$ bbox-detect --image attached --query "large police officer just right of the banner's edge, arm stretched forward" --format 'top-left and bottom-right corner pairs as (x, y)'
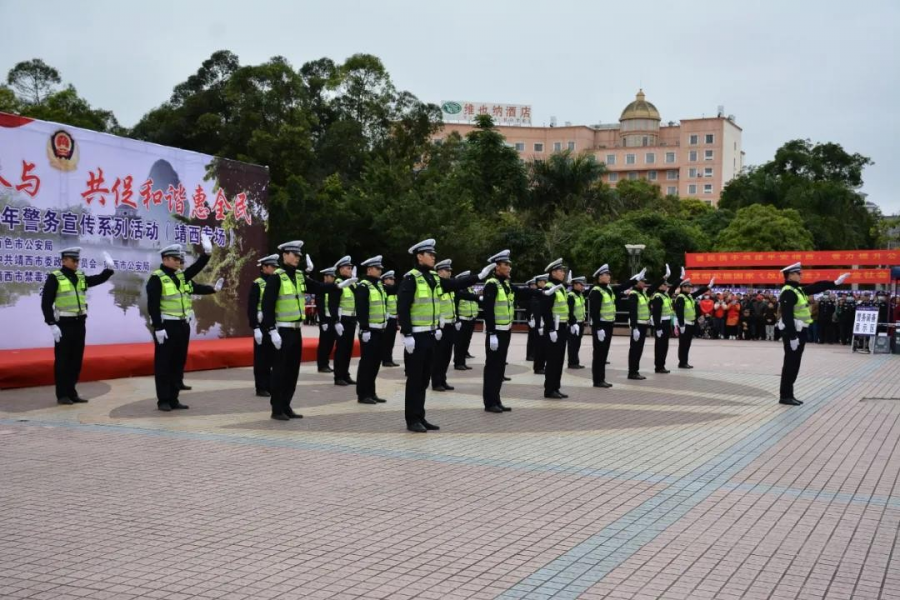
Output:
(262, 240), (355, 421)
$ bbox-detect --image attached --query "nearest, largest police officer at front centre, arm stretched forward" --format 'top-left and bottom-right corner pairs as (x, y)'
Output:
(397, 239), (493, 433)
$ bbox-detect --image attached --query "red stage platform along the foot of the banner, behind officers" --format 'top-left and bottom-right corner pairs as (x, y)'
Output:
(0, 337), (359, 389)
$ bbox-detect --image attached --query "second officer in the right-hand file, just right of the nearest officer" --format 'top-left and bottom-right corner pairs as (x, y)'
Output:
(482, 250), (541, 413)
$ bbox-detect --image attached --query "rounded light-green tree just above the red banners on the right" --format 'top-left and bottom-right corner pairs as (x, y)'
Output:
(716, 204), (815, 252)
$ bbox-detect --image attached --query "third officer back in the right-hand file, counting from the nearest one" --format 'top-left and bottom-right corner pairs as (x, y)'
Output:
(541, 258), (579, 399)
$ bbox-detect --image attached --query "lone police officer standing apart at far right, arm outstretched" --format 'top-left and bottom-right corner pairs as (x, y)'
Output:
(778, 263), (850, 406)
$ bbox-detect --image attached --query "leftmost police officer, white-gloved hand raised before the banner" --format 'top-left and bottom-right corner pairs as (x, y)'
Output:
(41, 247), (115, 404)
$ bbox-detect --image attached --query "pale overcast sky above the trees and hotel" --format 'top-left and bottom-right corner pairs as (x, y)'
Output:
(0, 0), (900, 213)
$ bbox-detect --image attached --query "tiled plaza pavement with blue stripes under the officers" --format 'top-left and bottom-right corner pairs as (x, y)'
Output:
(0, 328), (900, 600)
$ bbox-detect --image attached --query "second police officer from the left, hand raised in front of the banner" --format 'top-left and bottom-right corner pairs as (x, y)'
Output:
(147, 234), (224, 412)
